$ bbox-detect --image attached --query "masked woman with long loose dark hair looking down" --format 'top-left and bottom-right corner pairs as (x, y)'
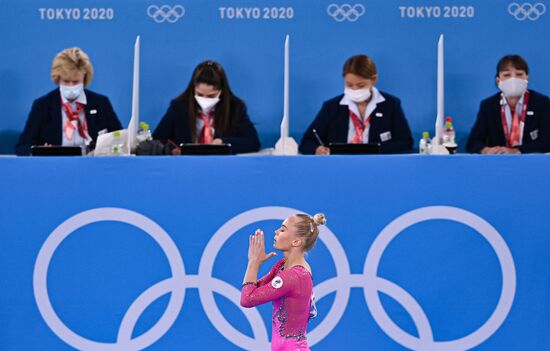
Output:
(153, 61), (260, 155)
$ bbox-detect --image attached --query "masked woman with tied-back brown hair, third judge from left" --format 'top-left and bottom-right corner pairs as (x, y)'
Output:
(300, 55), (413, 155)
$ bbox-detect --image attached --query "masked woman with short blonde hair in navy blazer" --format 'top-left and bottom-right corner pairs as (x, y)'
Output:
(15, 47), (122, 156)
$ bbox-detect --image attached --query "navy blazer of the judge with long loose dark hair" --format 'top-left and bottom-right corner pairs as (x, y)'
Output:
(153, 97), (260, 154)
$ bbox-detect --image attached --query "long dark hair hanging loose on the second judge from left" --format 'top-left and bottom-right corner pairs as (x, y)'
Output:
(176, 60), (234, 140)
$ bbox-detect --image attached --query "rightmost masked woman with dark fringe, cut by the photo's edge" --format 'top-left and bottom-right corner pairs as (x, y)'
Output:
(466, 55), (550, 154)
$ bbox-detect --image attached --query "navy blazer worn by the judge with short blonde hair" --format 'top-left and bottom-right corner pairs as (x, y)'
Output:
(15, 89), (122, 156)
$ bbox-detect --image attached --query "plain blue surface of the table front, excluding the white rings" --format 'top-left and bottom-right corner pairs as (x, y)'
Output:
(0, 155), (550, 351)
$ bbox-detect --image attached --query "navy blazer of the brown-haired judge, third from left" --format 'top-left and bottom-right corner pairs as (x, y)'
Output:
(300, 92), (413, 154)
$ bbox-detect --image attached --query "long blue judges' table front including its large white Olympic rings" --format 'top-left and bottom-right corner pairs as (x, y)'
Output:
(0, 155), (550, 351)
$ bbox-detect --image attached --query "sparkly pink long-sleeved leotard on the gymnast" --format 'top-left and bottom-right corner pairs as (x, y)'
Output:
(241, 259), (313, 351)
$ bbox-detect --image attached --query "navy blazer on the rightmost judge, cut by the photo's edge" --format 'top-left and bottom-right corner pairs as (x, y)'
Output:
(466, 90), (550, 153)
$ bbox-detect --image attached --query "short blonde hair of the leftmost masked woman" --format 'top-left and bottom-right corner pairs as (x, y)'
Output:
(52, 47), (94, 87)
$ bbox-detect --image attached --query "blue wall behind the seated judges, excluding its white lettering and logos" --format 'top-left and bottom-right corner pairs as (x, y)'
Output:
(0, 0), (550, 154)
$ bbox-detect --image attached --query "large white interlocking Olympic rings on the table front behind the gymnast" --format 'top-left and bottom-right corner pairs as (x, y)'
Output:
(33, 206), (516, 351)
